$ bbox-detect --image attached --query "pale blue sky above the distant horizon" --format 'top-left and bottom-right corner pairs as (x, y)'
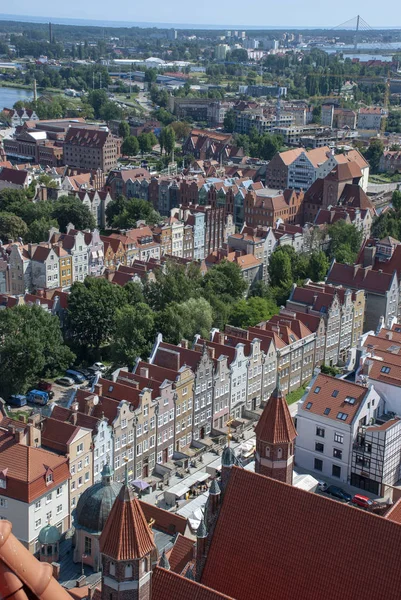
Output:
(0, 0), (394, 30)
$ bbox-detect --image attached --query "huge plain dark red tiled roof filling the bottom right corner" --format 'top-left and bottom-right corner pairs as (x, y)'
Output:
(201, 467), (401, 600)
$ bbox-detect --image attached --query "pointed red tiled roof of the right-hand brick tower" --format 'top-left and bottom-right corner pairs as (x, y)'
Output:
(255, 387), (297, 444)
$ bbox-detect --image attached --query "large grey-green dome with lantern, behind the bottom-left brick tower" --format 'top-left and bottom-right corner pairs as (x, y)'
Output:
(74, 464), (122, 533)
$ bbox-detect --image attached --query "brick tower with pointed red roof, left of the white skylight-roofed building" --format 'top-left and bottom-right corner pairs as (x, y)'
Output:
(255, 377), (297, 484)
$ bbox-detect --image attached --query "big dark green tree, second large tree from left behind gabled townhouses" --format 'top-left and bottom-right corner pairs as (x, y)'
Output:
(66, 277), (126, 349)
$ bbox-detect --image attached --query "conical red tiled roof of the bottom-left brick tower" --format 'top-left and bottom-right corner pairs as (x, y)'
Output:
(99, 485), (155, 560)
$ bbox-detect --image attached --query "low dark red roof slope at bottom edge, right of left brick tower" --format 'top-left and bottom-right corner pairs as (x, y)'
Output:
(152, 567), (233, 600)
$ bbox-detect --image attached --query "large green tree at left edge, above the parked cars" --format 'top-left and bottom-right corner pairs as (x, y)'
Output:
(0, 305), (75, 399)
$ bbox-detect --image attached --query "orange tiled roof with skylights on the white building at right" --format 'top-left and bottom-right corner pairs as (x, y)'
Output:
(302, 373), (368, 425)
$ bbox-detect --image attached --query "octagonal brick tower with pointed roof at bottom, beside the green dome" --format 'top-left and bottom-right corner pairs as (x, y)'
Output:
(99, 470), (157, 600)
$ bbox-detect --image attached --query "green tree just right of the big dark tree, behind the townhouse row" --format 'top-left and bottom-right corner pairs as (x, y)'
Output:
(111, 302), (155, 369)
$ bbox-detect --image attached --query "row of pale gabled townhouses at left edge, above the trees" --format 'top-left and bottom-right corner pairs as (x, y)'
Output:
(6, 225), (103, 295)
